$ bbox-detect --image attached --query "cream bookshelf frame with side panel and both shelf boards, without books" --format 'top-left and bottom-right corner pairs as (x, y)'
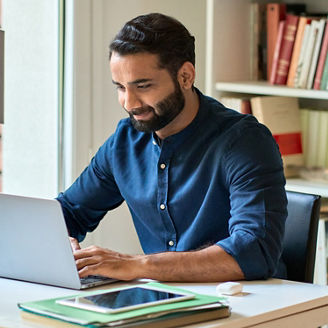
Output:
(205, 0), (328, 198)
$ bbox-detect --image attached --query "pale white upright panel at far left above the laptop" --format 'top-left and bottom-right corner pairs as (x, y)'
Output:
(2, 0), (58, 197)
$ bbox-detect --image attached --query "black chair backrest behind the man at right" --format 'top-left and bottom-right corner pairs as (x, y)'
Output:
(282, 191), (320, 283)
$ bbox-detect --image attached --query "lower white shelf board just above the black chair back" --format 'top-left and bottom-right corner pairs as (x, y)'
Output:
(286, 179), (328, 198)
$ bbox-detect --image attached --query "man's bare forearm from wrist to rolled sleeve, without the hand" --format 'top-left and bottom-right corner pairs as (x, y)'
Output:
(136, 245), (244, 282)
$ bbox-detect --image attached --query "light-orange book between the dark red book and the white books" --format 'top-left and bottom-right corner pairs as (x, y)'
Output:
(287, 16), (309, 87)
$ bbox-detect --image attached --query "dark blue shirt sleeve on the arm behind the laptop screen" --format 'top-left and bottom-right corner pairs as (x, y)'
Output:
(57, 138), (124, 241)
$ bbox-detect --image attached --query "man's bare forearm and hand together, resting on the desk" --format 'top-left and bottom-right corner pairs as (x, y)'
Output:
(74, 245), (244, 282)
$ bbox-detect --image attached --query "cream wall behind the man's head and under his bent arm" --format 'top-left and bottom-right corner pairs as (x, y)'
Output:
(66, 0), (206, 253)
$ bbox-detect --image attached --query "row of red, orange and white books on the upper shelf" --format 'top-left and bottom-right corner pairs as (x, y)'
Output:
(251, 3), (328, 90)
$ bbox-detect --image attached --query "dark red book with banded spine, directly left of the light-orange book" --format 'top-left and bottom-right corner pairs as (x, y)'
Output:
(275, 15), (299, 84)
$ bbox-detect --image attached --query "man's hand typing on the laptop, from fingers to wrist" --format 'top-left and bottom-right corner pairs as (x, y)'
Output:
(74, 246), (142, 280)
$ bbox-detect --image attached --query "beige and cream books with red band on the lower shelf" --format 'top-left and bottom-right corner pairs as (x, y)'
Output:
(219, 95), (328, 177)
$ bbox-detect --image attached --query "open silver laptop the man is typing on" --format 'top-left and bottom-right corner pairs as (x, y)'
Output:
(0, 193), (117, 289)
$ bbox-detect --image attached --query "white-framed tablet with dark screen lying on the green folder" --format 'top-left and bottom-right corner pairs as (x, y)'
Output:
(56, 286), (195, 313)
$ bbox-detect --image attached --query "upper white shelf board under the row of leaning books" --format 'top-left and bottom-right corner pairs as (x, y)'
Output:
(215, 81), (328, 100)
